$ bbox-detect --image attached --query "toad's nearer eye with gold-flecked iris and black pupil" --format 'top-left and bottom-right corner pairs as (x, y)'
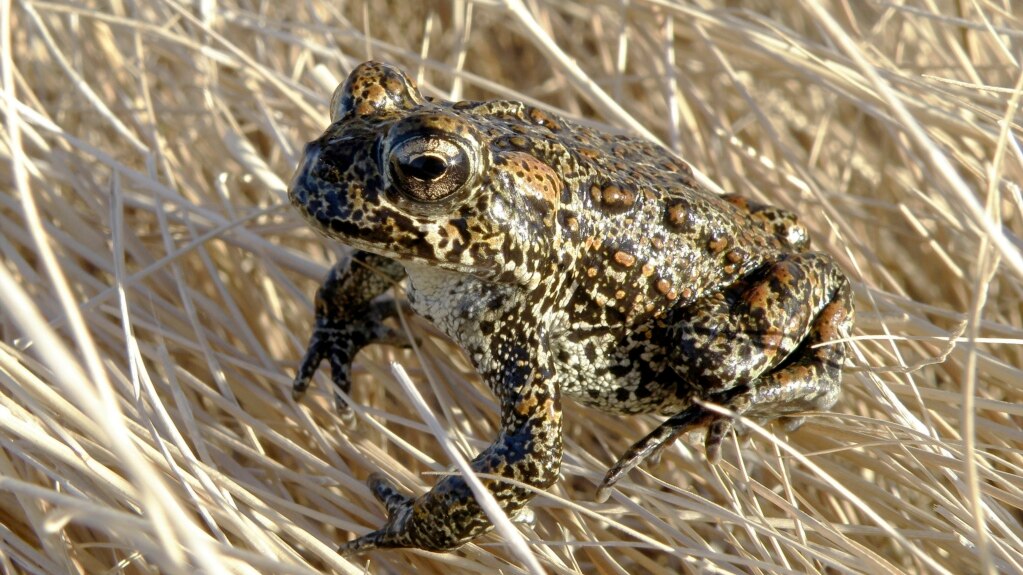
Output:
(389, 134), (473, 202)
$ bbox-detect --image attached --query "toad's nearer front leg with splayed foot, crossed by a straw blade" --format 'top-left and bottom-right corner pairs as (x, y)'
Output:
(338, 338), (562, 555)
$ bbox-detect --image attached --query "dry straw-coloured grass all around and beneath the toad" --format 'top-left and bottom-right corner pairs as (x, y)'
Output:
(0, 0), (1023, 573)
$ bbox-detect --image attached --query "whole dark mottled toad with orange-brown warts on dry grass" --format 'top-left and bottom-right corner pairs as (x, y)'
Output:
(290, 62), (852, 554)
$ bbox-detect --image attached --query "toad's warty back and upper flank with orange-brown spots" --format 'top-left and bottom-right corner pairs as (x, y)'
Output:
(441, 102), (793, 328)
